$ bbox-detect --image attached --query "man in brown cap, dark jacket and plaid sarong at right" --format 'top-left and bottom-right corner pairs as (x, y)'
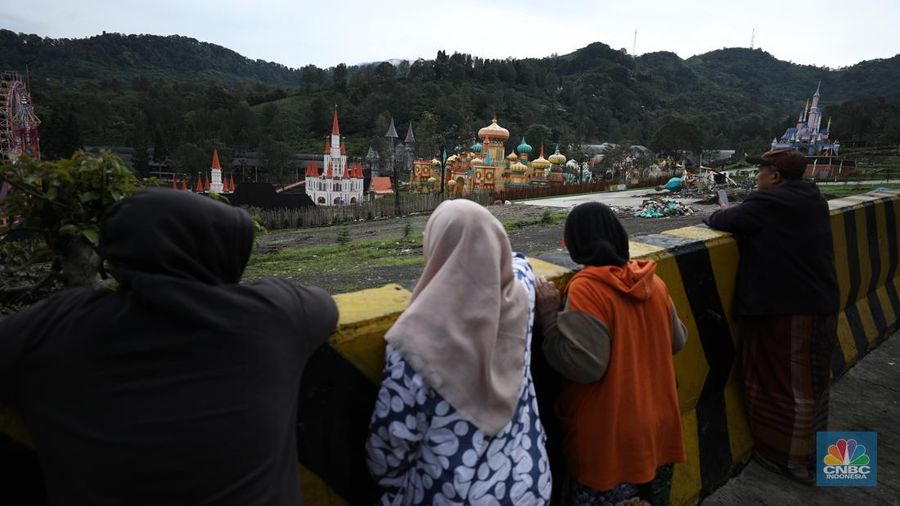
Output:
(706, 148), (839, 484)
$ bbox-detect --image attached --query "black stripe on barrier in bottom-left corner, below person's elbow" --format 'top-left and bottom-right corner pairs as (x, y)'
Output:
(0, 432), (47, 506)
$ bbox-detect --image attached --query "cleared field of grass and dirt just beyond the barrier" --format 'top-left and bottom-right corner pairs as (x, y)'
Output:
(244, 184), (900, 293)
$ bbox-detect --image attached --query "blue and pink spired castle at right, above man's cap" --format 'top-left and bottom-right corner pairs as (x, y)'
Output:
(772, 83), (856, 178)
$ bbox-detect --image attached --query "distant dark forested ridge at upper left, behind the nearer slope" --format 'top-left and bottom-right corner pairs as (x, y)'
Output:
(0, 30), (300, 86)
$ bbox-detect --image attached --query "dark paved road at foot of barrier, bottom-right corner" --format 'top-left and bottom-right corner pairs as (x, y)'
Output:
(701, 332), (900, 506)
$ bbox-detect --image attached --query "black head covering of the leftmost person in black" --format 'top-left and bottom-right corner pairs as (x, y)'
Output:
(99, 189), (253, 289)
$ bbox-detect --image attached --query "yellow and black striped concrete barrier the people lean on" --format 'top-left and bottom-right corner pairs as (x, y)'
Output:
(0, 191), (900, 505)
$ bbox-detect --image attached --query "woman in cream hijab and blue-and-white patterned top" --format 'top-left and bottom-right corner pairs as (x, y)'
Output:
(367, 200), (551, 505)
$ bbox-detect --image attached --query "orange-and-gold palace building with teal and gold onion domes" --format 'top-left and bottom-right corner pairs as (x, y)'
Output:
(410, 118), (566, 196)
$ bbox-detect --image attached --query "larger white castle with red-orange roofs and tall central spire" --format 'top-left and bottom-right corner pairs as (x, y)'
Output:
(306, 109), (363, 206)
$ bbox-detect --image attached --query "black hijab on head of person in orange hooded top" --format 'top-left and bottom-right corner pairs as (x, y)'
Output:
(565, 202), (629, 267)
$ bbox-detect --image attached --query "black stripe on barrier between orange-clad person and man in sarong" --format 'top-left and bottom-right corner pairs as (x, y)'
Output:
(672, 238), (735, 493)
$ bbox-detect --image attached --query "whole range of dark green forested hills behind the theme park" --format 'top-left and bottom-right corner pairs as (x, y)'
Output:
(0, 31), (900, 175)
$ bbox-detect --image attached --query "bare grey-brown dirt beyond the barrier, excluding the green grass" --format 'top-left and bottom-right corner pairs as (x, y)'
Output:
(254, 198), (717, 293)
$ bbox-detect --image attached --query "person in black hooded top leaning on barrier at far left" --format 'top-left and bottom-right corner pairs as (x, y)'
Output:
(0, 190), (337, 506)
